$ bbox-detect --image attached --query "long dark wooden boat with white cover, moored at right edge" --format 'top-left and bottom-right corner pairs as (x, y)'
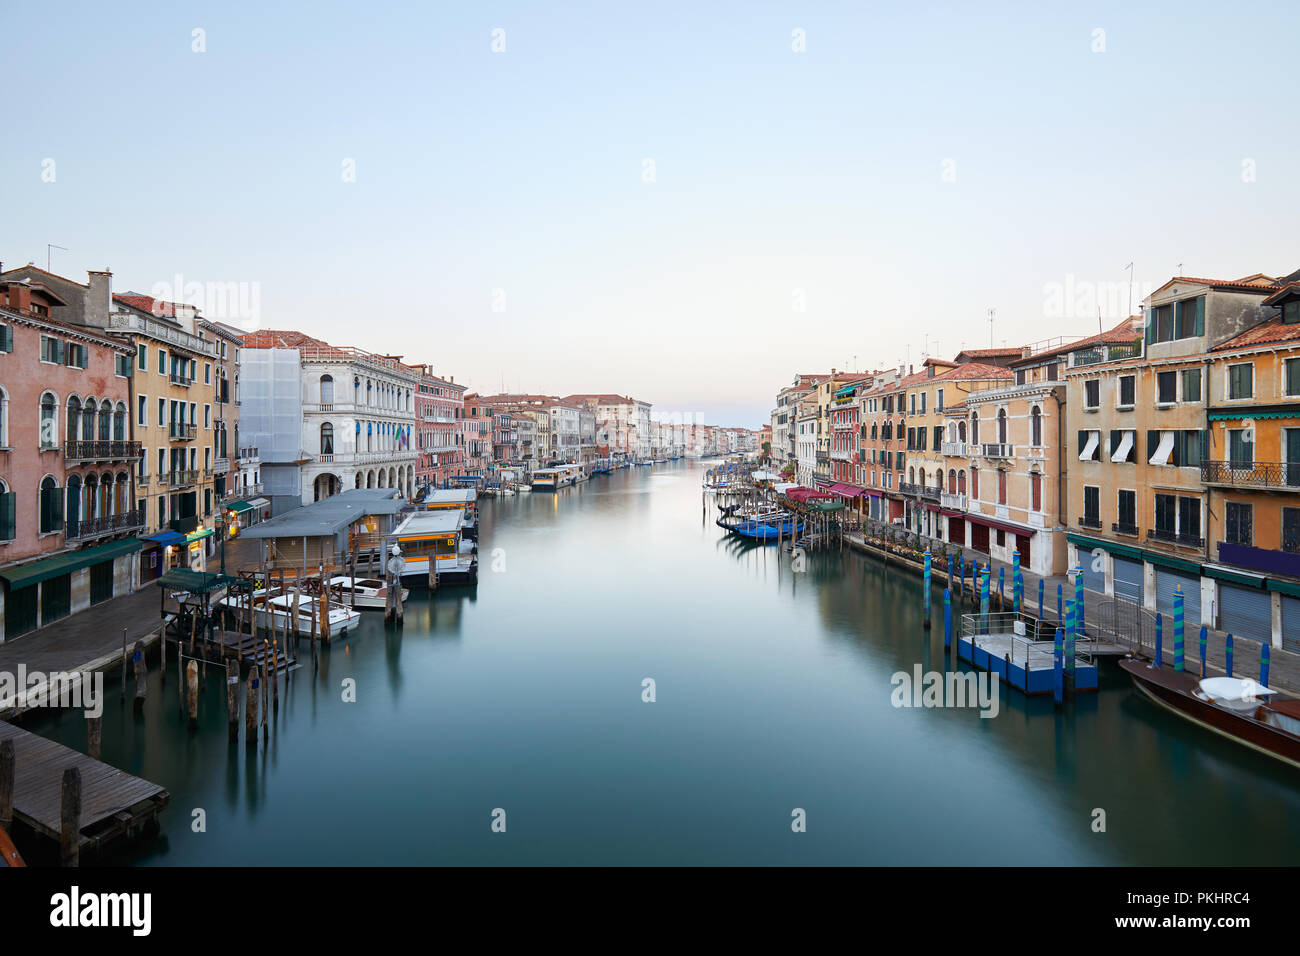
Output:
(1119, 657), (1300, 767)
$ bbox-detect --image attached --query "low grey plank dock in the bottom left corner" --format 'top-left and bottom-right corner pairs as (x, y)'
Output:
(0, 722), (170, 852)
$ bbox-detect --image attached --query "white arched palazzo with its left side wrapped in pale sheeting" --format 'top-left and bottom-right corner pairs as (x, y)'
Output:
(239, 330), (420, 515)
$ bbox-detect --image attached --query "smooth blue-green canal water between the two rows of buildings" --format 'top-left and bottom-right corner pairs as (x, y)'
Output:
(17, 460), (1300, 865)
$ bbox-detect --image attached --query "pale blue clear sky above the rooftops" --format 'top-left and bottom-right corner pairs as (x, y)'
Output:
(0, 0), (1300, 427)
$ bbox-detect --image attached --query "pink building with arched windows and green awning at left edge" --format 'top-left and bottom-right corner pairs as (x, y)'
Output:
(0, 271), (143, 641)
